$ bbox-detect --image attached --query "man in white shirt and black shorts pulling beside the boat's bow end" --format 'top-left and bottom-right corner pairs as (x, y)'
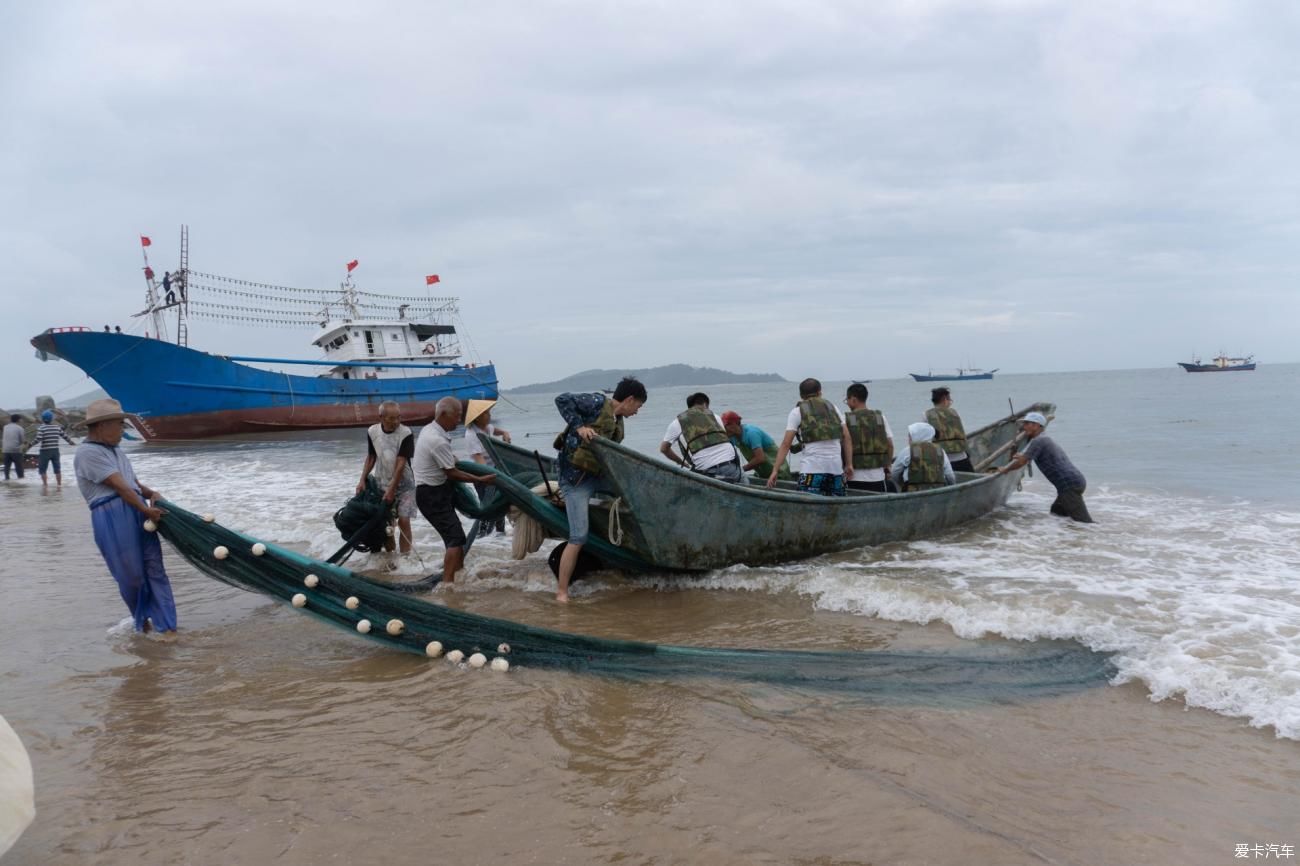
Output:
(412, 397), (497, 584)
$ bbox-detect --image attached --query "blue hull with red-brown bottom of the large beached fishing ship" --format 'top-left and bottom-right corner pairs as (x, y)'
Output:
(31, 330), (497, 441)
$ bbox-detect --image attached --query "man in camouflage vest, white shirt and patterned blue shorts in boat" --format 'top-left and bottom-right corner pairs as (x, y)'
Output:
(767, 378), (853, 497)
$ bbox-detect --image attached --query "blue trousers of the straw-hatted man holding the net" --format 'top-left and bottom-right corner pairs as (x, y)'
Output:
(90, 495), (176, 632)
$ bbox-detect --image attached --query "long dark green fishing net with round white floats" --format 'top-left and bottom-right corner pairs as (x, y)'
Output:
(149, 491), (1112, 702)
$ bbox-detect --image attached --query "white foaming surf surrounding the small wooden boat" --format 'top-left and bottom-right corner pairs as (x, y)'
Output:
(134, 443), (1300, 739)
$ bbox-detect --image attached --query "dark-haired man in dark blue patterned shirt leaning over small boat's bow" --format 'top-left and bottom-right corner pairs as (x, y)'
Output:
(555, 376), (647, 602)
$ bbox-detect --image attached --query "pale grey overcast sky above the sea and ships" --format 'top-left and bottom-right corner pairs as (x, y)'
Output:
(0, 0), (1300, 406)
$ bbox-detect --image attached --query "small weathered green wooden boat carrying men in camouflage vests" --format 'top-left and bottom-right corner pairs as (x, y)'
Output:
(467, 403), (1056, 571)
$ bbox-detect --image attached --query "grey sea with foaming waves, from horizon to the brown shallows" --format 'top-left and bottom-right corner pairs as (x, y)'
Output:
(91, 364), (1300, 739)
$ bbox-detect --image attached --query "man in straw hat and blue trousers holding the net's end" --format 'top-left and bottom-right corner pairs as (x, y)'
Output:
(73, 399), (177, 632)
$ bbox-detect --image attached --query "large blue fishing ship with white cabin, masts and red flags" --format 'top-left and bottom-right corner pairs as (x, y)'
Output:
(31, 229), (497, 441)
